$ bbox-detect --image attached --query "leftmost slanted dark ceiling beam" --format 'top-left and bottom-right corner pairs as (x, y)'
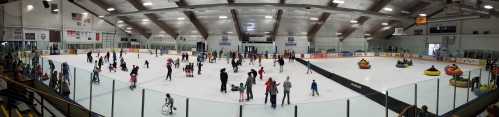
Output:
(90, 0), (151, 39)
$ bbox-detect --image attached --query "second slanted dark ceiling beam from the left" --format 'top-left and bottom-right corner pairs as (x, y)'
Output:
(127, 0), (178, 39)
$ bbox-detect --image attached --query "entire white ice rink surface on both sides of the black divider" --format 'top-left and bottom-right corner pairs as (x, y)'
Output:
(40, 53), (488, 117)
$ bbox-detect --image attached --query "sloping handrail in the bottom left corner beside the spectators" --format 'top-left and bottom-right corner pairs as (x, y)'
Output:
(0, 74), (89, 116)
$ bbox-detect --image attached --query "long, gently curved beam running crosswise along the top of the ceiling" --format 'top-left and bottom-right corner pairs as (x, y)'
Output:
(108, 1), (414, 20)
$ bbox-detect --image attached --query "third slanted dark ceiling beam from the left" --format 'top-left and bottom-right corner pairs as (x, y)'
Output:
(175, 0), (208, 40)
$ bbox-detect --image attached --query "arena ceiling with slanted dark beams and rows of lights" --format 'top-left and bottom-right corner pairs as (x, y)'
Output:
(70, 0), (499, 40)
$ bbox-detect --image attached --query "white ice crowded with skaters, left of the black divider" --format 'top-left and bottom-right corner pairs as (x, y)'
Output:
(44, 53), (360, 116)
